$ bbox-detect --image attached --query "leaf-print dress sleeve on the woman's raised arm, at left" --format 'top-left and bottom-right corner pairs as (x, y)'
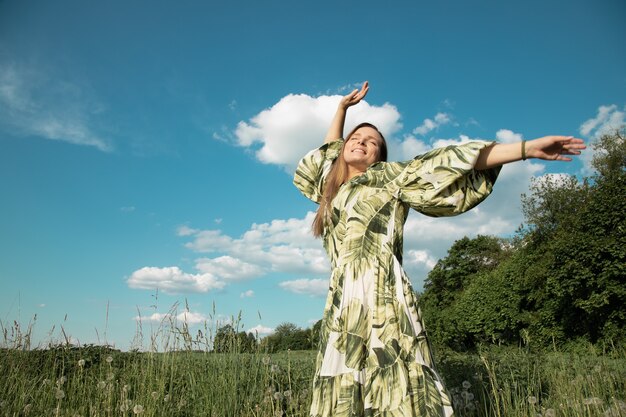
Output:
(293, 139), (343, 204)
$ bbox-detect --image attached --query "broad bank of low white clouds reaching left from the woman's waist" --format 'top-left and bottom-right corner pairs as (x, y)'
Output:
(127, 212), (329, 292)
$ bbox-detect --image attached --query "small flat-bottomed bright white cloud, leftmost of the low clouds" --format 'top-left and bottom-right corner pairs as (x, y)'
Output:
(127, 266), (225, 294)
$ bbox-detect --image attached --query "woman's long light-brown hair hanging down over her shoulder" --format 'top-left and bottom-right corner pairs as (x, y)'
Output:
(312, 122), (387, 237)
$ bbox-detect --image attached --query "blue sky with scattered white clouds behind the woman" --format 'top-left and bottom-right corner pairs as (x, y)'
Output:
(0, 0), (626, 349)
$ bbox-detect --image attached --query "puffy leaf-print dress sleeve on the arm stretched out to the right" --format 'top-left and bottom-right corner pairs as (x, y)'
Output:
(389, 141), (501, 217)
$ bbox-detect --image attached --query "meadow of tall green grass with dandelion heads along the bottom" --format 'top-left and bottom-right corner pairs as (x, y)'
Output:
(0, 316), (626, 417)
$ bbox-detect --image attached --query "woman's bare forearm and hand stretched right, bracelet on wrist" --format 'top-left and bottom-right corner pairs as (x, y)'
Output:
(474, 136), (586, 170)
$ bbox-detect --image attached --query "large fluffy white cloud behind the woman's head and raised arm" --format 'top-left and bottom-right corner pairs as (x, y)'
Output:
(235, 94), (401, 171)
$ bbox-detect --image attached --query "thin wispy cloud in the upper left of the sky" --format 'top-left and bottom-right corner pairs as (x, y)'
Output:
(0, 64), (111, 151)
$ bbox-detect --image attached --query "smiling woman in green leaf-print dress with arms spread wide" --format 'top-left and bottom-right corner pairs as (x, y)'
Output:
(294, 82), (585, 417)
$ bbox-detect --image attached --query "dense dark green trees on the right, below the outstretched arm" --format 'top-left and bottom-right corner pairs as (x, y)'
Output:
(420, 133), (626, 350)
